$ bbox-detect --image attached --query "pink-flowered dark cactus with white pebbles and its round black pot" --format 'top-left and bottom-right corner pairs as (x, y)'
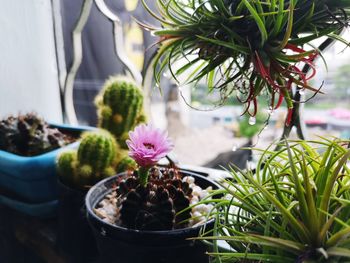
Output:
(86, 124), (217, 263)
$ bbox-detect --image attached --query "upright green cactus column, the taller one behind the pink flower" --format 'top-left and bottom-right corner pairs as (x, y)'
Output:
(95, 77), (145, 148)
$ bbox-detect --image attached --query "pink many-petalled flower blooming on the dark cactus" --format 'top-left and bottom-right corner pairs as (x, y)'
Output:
(126, 124), (174, 168)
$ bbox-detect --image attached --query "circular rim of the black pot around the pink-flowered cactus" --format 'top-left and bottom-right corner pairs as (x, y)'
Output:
(85, 169), (220, 235)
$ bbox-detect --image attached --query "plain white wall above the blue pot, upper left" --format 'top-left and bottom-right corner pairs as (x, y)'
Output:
(0, 0), (62, 122)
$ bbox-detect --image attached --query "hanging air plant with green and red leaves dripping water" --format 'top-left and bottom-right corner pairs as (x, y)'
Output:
(140, 0), (350, 125)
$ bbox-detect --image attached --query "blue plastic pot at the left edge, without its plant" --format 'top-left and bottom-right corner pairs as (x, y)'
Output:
(0, 124), (95, 206)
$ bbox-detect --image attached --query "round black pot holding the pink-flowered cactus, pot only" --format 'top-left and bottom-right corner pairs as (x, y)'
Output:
(85, 171), (218, 263)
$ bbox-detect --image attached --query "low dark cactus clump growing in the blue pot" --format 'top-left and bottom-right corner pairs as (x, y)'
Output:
(0, 113), (72, 156)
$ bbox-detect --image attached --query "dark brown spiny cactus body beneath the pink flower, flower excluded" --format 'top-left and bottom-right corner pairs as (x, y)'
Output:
(116, 168), (192, 230)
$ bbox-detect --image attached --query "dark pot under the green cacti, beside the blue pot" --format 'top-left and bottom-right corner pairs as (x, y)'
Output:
(58, 181), (98, 263)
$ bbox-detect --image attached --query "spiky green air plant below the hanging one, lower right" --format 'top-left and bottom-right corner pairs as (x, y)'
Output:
(203, 139), (350, 262)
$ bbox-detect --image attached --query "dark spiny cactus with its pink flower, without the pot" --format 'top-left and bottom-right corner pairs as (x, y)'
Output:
(112, 124), (196, 230)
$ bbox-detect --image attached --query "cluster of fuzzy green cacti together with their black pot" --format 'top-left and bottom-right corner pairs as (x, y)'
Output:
(57, 76), (144, 262)
